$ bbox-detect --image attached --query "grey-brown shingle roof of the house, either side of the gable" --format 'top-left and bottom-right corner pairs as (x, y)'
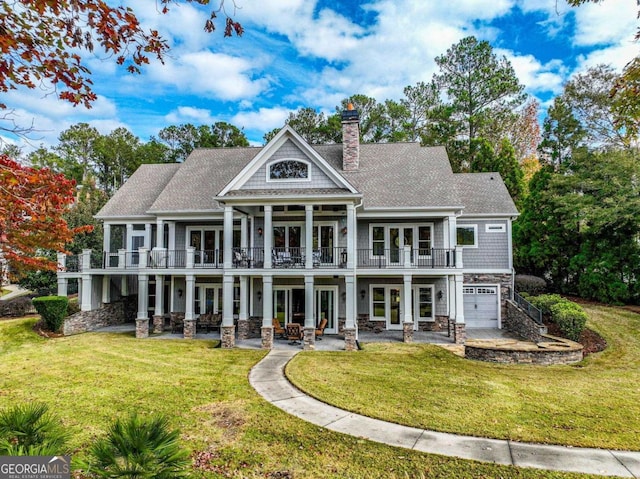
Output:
(97, 139), (517, 218)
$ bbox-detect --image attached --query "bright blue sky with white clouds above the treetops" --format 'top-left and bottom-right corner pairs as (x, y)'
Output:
(3, 0), (640, 151)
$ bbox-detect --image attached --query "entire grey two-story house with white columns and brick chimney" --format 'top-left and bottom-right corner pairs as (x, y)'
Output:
(58, 109), (517, 350)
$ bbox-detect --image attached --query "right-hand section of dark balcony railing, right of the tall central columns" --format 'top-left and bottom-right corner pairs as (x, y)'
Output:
(357, 248), (456, 269)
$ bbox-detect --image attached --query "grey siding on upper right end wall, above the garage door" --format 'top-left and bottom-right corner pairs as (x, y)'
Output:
(458, 220), (510, 269)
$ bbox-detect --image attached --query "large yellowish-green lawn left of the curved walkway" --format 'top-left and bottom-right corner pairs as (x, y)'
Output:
(0, 319), (620, 479)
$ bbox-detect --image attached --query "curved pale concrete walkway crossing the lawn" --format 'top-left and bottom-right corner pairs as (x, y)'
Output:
(249, 350), (640, 478)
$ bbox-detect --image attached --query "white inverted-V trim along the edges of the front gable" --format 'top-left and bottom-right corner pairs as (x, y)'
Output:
(217, 125), (358, 198)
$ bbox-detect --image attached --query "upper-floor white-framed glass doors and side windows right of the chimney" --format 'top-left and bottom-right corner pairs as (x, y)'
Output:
(369, 223), (433, 256)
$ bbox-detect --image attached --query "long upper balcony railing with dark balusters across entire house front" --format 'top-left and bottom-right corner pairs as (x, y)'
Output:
(58, 246), (462, 273)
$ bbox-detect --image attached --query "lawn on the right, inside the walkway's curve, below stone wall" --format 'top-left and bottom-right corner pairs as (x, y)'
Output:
(286, 306), (640, 450)
